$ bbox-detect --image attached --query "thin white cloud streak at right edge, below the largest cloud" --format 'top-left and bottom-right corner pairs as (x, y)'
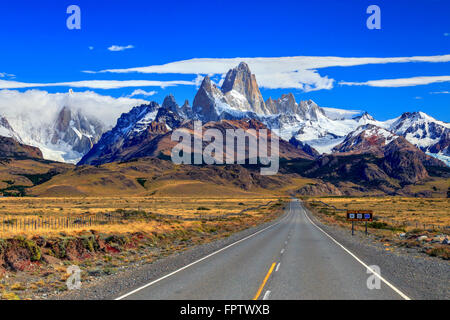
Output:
(339, 76), (450, 88)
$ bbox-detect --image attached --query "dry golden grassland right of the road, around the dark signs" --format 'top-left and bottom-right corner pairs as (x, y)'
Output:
(305, 197), (450, 260)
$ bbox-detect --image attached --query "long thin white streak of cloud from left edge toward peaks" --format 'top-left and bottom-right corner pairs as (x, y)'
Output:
(0, 80), (195, 89)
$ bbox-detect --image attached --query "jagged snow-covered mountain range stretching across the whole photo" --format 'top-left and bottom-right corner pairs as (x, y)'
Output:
(0, 63), (450, 165)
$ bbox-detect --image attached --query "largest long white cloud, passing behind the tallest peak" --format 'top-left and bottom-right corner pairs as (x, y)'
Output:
(82, 55), (450, 91)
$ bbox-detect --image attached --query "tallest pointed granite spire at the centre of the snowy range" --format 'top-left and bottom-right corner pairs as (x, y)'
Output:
(222, 62), (268, 114)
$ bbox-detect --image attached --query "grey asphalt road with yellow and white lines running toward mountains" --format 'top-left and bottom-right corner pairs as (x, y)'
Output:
(118, 200), (408, 300)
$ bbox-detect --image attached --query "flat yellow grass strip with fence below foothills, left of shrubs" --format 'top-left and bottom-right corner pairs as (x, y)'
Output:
(0, 197), (286, 238)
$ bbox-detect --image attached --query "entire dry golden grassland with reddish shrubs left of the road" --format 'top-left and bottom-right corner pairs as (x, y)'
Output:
(0, 197), (287, 300)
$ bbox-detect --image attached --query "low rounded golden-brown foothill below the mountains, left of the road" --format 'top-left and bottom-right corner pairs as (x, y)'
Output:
(29, 157), (303, 197)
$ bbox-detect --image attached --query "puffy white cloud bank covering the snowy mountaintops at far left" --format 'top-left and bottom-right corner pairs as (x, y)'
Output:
(0, 89), (148, 127)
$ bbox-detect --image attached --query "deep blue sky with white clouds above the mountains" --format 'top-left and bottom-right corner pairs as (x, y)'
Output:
(0, 0), (450, 122)
